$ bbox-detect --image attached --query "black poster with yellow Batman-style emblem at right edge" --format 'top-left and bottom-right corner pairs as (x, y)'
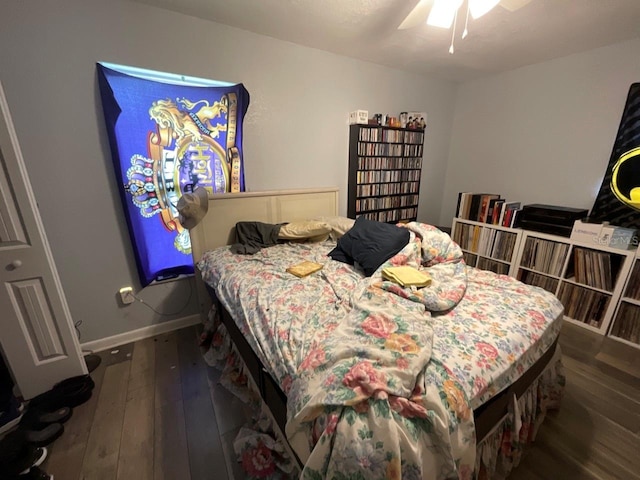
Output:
(590, 83), (640, 228)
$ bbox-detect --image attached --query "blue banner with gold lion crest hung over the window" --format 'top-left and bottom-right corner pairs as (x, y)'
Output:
(97, 63), (249, 286)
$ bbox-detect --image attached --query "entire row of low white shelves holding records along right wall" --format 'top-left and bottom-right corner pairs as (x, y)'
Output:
(451, 218), (640, 338)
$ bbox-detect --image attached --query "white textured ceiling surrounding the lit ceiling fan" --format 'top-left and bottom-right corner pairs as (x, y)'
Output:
(138, 0), (640, 81)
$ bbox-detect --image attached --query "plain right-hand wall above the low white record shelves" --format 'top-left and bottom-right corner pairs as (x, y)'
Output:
(440, 40), (640, 225)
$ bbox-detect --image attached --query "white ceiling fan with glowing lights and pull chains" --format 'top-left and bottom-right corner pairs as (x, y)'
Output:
(398, 0), (531, 53)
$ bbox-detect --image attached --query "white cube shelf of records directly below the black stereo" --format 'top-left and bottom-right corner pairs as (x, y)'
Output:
(514, 230), (640, 334)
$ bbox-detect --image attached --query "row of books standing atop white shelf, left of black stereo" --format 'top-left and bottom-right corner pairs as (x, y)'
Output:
(456, 192), (521, 227)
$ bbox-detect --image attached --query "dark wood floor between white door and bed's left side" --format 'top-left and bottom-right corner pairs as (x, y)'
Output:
(45, 327), (246, 480)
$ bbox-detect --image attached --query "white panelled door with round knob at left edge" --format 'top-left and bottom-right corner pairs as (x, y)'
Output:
(0, 84), (87, 399)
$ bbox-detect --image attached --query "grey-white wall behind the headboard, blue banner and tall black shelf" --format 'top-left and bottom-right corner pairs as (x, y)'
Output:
(0, 0), (455, 341)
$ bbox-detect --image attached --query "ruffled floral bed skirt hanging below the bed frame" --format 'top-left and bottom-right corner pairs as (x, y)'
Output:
(201, 310), (565, 480)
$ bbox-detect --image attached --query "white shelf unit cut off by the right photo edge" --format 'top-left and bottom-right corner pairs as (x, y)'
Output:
(609, 251), (640, 348)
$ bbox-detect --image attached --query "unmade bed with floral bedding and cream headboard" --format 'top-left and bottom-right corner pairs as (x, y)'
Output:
(191, 189), (563, 479)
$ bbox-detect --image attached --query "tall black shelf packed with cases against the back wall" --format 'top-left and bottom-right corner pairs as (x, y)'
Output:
(347, 125), (424, 222)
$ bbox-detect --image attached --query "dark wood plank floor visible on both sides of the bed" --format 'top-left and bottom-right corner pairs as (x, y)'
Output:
(45, 324), (640, 480)
